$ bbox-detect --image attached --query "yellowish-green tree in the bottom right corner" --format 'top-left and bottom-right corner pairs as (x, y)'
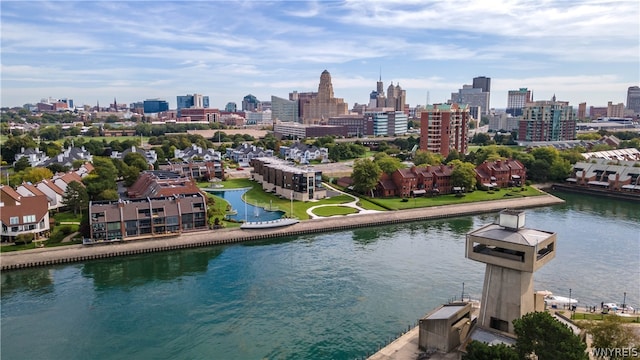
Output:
(587, 316), (640, 356)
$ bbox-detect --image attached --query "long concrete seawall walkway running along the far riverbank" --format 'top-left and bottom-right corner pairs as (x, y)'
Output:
(0, 194), (564, 270)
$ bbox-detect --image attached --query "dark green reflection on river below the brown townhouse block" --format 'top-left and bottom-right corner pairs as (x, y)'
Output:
(82, 246), (224, 290)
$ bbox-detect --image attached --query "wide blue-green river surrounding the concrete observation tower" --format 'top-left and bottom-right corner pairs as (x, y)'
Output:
(0, 193), (640, 360)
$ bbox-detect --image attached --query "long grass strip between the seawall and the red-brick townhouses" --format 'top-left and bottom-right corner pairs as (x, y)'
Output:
(364, 186), (541, 210)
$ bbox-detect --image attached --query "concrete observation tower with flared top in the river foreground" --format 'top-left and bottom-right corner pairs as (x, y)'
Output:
(465, 210), (556, 334)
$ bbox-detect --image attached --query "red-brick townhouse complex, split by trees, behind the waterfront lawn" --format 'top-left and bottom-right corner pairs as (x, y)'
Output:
(374, 159), (527, 197)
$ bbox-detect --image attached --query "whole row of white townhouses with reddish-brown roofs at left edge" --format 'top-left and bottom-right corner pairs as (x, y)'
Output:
(0, 163), (93, 241)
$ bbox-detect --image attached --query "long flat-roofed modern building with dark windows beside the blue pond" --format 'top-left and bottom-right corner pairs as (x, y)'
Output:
(251, 157), (327, 201)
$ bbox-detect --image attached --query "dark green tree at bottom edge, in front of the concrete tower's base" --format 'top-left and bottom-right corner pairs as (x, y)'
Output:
(513, 312), (589, 360)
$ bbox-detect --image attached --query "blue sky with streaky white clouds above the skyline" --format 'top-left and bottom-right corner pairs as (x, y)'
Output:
(0, 0), (640, 108)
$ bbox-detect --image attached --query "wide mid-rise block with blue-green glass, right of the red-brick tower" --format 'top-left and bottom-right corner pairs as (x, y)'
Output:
(518, 95), (577, 141)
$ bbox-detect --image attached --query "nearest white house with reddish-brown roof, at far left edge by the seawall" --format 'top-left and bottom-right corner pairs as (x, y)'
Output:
(0, 185), (50, 241)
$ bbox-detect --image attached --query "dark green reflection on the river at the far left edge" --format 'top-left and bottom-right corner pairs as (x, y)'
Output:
(0, 268), (53, 297)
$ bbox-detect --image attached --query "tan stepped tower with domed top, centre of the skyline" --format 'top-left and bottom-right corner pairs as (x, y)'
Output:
(302, 70), (349, 124)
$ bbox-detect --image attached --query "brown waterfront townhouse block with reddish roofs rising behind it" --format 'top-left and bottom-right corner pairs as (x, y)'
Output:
(89, 170), (207, 241)
